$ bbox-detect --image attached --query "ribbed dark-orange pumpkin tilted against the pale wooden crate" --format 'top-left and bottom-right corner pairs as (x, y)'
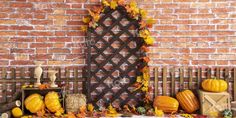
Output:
(176, 90), (199, 113)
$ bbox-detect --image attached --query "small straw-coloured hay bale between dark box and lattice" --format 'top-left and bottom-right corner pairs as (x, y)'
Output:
(65, 94), (86, 113)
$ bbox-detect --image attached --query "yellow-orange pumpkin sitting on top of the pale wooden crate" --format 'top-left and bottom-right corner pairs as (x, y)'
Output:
(202, 78), (228, 92)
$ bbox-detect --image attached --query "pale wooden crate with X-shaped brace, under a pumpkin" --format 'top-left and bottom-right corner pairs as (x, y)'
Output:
(199, 90), (230, 117)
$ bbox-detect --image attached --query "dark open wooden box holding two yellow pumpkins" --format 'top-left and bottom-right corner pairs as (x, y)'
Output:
(22, 87), (64, 114)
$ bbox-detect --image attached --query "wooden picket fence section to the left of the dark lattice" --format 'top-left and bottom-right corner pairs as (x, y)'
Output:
(0, 67), (85, 103)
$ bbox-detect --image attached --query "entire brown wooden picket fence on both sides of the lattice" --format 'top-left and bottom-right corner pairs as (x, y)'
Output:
(0, 67), (236, 103)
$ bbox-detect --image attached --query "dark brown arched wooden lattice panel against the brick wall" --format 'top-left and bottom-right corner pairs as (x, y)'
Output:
(87, 7), (144, 106)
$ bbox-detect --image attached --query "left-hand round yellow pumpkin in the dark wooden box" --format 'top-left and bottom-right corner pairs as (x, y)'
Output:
(24, 93), (44, 113)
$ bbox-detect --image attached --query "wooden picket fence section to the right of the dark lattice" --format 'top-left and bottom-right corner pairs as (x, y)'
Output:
(154, 67), (236, 100)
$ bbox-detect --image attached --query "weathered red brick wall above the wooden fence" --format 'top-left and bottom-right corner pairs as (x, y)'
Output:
(0, 0), (236, 66)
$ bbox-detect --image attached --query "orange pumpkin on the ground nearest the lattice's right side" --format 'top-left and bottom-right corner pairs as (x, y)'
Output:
(153, 96), (179, 113)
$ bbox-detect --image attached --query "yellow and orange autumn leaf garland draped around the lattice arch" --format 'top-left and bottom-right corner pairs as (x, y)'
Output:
(81, 0), (154, 97)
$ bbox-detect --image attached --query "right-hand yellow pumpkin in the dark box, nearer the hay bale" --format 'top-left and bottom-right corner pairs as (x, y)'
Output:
(44, 91), (62, 113)
